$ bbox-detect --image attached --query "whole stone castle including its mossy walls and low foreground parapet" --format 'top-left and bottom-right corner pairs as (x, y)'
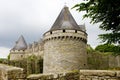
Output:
(0, 6), (120, 80)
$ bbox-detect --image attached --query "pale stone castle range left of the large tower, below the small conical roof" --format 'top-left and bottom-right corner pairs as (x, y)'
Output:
(10, 40), (44, 60)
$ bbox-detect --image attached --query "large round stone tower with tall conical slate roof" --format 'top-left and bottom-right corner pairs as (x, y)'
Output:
(43, 6), (87, 73)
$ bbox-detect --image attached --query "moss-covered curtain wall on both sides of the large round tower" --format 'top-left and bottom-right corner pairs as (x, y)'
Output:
(0, 52), (120, 74)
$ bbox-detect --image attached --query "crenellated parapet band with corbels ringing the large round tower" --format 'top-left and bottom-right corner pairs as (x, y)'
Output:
(44, 30), (87, 43)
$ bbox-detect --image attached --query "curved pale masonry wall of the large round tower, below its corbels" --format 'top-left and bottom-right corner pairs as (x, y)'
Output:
(43, 40), (87, 73)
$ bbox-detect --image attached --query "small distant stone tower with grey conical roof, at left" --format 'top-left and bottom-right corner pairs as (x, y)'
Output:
(10, 35), (27, 60)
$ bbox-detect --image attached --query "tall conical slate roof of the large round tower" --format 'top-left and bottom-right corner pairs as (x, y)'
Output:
(50, 6), (81, 31)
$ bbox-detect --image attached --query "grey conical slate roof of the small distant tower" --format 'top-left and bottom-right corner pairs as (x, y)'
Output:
(12, 35), (27, 50)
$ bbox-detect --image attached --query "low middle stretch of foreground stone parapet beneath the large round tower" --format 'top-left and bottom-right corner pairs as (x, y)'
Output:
(27, 72), (79, 80)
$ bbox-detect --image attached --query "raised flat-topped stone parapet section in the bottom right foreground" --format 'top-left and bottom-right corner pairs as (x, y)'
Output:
(79, 70), (120, 80)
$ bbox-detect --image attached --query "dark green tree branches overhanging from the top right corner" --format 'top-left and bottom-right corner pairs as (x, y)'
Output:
(73, 0), (120, 44)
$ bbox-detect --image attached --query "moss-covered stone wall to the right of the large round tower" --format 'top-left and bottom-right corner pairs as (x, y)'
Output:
(87, 51), (120, 70)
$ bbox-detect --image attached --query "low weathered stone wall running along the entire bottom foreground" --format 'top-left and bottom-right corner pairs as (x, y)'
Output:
(0, 64), (120, 80)
